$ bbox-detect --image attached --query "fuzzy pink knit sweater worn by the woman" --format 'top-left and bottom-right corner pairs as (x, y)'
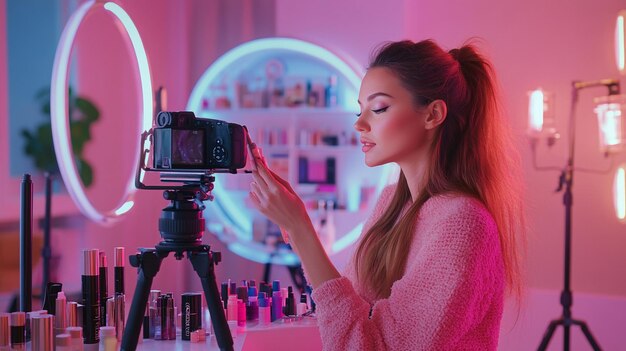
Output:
(313, 185), (504, 351)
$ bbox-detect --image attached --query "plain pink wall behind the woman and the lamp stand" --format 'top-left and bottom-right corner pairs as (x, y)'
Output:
(404, 0), (626, 295)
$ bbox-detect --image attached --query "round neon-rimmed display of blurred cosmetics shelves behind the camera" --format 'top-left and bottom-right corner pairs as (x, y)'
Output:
(187, 38), (390, 264)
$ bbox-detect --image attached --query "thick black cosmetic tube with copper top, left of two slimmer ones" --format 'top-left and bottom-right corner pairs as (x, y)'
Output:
(81, 249), (100, 344)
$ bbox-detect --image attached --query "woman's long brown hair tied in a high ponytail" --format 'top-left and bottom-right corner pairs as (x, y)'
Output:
(355, 40), (525, 298)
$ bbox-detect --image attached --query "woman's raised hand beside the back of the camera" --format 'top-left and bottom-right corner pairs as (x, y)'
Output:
(250, 158), (311, 241)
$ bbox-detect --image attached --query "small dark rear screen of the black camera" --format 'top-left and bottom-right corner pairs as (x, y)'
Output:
(172, 129), (205, 166)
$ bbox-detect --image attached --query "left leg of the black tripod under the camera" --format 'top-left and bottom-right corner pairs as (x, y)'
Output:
(121, 249), (163, 351)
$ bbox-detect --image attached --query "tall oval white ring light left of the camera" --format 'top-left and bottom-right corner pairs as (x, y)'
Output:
(50, 0), (153, 224)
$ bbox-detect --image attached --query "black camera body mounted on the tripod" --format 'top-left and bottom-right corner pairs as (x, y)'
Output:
(153, 111), (247, 172)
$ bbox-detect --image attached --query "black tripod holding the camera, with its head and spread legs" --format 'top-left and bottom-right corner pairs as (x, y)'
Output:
(121, 183), (233, 350)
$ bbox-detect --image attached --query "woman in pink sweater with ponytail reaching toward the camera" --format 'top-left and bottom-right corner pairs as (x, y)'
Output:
(250, 40), (524, 350)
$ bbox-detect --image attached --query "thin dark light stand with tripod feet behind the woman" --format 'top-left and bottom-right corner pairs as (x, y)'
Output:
(538, 79), (619, 351)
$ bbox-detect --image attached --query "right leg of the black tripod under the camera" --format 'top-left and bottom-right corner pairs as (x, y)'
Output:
(189, 248), (234, 351)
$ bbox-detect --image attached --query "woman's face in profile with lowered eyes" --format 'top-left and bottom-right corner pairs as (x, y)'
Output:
(354, 67), (428, 167)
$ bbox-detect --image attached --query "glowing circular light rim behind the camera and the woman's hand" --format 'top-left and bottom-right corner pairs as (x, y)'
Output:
(187, 38), (393, 265)
